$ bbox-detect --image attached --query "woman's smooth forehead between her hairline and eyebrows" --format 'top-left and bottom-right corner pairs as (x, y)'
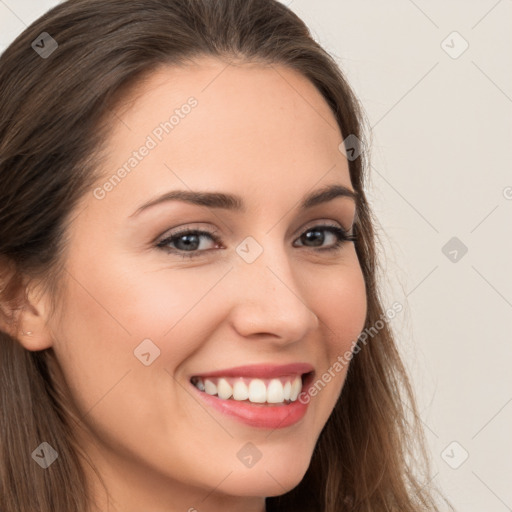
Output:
(88, 58), (351, 218)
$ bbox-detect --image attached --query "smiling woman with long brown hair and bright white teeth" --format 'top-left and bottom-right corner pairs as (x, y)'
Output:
(0, 0), (456, 512)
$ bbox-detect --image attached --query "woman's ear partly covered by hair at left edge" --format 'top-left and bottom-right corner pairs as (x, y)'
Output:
(0, 276), (53, 351)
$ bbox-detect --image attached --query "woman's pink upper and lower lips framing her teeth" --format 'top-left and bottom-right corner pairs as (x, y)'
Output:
(190, 364), (313, 429)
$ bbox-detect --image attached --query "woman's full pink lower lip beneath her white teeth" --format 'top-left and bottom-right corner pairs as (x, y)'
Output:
(190, 375), (311, 429)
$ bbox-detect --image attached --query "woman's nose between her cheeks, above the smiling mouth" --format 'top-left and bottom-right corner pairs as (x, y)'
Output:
(226, 243), (319, 345)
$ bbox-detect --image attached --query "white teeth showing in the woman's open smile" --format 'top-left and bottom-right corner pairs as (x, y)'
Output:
(192, 376), (302, 404)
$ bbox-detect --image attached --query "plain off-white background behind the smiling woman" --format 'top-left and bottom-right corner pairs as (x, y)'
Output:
(0, 0), (512, 512)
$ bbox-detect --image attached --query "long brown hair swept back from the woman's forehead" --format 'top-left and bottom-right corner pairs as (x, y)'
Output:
(0, 0), (456, 512)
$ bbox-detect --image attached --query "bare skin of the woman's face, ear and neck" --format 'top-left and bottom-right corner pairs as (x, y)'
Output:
(17, 58), (366, 512)
